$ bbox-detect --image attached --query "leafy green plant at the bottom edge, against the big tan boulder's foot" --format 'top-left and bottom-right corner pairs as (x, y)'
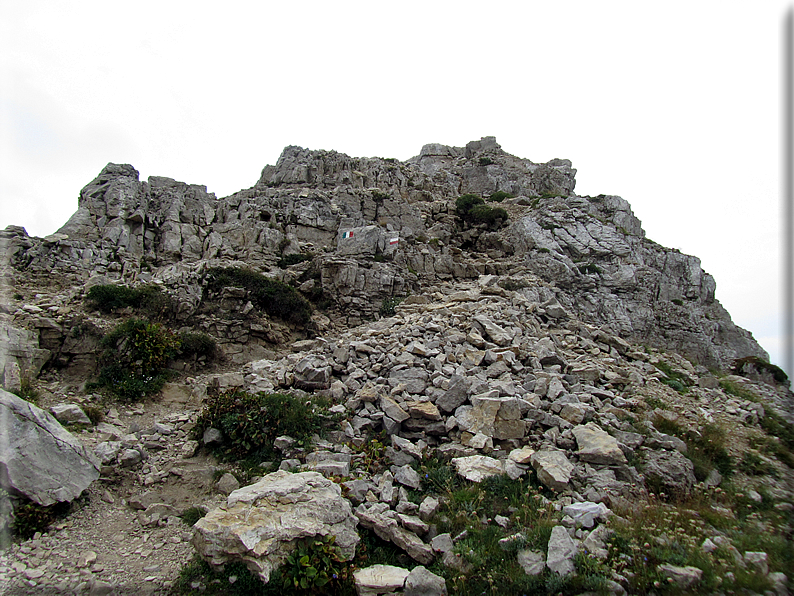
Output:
(281, 536), (352, 594)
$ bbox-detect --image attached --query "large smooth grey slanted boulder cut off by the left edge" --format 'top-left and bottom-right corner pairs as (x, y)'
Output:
(0, 389), (100, 507)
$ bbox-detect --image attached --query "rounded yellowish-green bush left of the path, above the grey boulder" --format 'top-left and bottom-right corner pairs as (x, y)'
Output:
(86, 318), (180, 401)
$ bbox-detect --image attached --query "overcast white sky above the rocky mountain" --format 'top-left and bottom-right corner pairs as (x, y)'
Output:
(0, 0), (794, 373)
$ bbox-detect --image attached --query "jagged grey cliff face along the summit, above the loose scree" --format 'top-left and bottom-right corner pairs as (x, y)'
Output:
(1, 137), (767, 367)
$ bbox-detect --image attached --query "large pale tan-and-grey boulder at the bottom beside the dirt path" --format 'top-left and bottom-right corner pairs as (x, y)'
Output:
(193, 471), (359, 583)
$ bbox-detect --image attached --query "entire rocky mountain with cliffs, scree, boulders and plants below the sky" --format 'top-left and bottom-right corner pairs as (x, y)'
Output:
(0, 137), (794, 594)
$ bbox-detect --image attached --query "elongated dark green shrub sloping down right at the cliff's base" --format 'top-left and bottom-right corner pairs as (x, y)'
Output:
(206, 267), (312, 325)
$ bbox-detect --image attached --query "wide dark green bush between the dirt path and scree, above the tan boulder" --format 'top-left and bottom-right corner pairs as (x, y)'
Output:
(193, 391), (330, 461)
